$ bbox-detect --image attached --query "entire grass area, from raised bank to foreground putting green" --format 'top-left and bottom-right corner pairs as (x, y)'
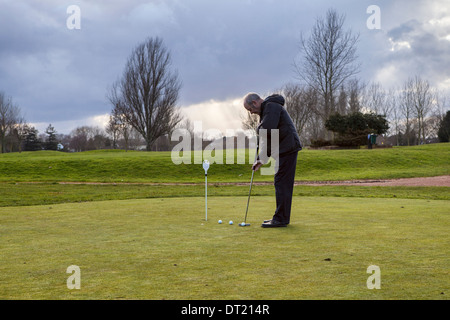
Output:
(0, 143), (450, 300)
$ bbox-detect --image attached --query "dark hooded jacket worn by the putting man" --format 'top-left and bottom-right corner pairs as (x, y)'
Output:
(257, 94), (302, 162)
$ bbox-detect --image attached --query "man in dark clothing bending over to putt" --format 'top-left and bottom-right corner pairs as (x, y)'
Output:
(244, 93), (302, 228)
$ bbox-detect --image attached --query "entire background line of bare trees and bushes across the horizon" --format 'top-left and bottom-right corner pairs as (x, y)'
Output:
(0, 9), (450, 153)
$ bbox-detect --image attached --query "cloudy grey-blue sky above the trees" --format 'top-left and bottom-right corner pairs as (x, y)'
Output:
(0, 0), (450, 133)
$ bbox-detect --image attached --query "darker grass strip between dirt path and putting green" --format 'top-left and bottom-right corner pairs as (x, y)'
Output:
(0, 182), (450, 207)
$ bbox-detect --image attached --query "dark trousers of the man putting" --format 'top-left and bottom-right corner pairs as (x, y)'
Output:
(272, 152), (298, 224)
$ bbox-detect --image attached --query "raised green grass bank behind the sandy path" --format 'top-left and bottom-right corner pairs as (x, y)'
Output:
(0, 143), (450, 182)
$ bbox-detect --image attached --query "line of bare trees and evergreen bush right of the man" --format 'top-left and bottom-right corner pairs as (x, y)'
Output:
(243, 9), (450, 146)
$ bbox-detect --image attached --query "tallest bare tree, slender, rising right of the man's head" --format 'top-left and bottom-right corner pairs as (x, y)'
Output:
(294, 9), (360, 135)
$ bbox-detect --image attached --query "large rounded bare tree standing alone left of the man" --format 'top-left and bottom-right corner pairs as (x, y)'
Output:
(108, 38), (182, 151)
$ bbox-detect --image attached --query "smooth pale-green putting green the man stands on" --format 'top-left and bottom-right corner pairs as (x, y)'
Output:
(0, 196), (450, 300)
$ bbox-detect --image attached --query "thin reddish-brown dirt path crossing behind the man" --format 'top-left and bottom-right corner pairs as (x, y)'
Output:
(59, 176), (450, 187)
